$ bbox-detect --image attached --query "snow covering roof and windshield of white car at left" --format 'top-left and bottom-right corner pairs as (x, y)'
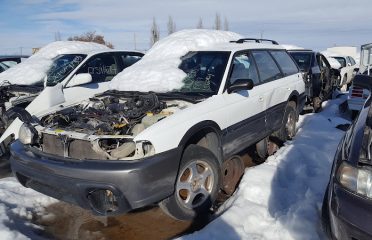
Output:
(0, 41), (109, 84)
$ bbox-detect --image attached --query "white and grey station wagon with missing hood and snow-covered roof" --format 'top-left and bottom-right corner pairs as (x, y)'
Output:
(11, 30), (305, 220)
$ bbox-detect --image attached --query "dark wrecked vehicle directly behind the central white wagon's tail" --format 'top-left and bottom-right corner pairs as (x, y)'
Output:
(288, 49), (340, 112)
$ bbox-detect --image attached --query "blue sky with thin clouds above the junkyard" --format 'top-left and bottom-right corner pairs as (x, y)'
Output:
(0, 0), (372, 54)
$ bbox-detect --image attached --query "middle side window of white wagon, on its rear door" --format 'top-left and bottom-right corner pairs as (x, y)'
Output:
(252, 51), (282, 82)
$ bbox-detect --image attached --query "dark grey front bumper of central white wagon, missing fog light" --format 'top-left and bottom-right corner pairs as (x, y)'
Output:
(11, 141), (181, 215)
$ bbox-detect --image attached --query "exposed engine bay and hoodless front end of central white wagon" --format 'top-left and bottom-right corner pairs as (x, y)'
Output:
(26, 92), (191, 160)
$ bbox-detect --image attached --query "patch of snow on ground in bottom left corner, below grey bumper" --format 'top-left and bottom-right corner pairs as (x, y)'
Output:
(0, 177), (57, 240)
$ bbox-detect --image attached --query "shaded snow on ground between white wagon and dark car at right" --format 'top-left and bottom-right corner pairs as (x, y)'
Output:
(182, 96), (349, 240)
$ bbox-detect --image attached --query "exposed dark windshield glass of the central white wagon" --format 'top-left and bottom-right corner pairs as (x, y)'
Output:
(174, 51), (230, 96)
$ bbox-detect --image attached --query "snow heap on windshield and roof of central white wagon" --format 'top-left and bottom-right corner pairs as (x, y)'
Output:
(110, 29), (242, 92)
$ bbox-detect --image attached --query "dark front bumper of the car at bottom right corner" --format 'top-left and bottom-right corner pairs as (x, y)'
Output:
(328, 183), (372, 240)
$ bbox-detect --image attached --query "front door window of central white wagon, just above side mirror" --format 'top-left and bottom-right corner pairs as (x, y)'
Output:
(229, 53), (260, 85)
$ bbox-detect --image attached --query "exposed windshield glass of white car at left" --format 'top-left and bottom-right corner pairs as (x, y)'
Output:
(46, 54), (86, 86)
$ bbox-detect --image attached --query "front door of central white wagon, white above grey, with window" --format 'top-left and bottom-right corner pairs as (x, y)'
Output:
(223, 52), (266, 156)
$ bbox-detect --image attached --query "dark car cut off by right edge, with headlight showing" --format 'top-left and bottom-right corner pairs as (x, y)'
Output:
(322, 75), (372, 240)
